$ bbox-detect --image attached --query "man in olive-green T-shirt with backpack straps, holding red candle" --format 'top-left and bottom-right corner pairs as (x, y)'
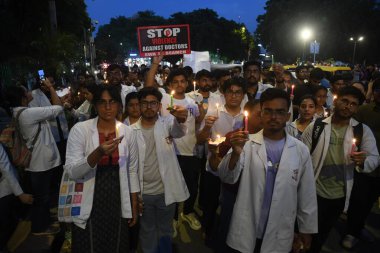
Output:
(302, 87), (379, 253)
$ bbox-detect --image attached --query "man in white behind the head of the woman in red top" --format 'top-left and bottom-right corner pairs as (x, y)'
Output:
(106, 64), (136, 112)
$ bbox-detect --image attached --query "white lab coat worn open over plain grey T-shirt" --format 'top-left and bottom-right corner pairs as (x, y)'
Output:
(131, 115), (190, 206)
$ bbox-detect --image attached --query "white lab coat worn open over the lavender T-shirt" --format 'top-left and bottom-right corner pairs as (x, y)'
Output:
(218, 131), (318, 253)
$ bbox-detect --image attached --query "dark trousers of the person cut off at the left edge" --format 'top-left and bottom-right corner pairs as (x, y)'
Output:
(0, 194), (18, 251)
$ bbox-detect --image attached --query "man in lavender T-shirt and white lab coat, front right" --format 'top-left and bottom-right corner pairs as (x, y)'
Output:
(218, 88), (317, 253)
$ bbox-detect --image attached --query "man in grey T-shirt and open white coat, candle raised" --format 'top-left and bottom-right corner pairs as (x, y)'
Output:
(131, 87), (189, 253)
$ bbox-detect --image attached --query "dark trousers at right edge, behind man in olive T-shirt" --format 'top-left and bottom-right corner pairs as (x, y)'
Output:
(347, 171), (380, 237)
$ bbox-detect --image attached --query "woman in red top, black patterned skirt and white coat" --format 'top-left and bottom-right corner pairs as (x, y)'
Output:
(64, 85), (140, 253)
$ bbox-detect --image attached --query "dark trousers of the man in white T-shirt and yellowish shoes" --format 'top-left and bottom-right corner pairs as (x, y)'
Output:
(174, 155), (200, 219)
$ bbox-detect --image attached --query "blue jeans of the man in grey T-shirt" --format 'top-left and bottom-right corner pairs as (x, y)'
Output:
(139, 194), (175, 253)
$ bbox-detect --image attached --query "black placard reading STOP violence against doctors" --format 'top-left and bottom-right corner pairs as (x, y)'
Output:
(137, 25), (191, 57)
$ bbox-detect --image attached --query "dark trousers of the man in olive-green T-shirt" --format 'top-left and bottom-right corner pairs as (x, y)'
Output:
(310, 196), (345, 253)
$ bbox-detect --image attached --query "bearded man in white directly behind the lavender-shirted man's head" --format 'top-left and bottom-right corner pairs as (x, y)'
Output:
(243, 61), (273, 100)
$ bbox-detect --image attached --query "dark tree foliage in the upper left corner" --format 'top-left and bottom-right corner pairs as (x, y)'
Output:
(0, 0), (91, 79)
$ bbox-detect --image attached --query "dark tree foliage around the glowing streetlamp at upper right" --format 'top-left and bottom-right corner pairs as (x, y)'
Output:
(255, 0), (380, 62)
